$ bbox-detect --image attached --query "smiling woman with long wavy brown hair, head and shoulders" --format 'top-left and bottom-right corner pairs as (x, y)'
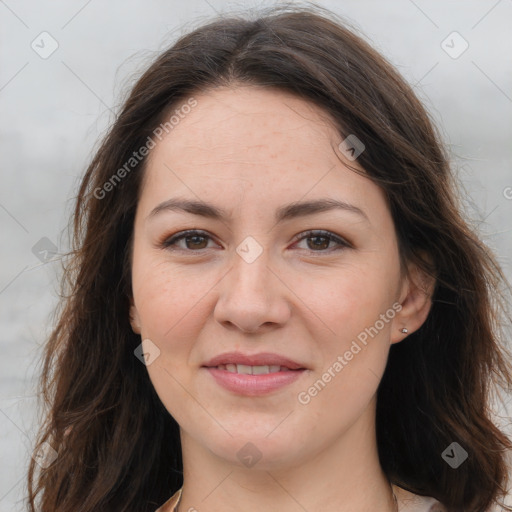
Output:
(29, 7), (512, 512)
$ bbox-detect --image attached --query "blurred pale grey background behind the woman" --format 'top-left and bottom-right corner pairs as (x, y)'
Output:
(0, 0), (512, 512)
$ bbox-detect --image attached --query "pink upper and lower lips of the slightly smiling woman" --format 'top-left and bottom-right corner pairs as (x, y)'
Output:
(203, 352), (306, 396)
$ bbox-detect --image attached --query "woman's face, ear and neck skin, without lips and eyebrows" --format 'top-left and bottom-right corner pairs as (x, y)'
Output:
(130, 85), (433, 512)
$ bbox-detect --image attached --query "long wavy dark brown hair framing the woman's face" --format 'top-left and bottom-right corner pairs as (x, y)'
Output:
(28, 5), (512, 512)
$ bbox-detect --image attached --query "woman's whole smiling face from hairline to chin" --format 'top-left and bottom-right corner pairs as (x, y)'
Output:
(131, 86), (421, 468)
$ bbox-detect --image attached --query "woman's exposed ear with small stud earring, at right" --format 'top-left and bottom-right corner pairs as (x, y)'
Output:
(391, 258), (436, 343)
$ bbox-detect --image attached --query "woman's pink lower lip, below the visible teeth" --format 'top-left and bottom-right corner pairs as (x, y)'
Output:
(205, 367), (306, 396)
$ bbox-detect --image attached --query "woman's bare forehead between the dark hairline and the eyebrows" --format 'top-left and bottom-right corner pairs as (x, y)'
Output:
(141, 86), (385, 225)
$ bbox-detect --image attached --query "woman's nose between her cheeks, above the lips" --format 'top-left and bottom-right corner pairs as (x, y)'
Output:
(214, 246), (291, 333)
